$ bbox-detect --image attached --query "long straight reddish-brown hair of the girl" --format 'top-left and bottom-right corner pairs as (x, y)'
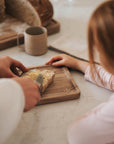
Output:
(88, 0), (114, 84)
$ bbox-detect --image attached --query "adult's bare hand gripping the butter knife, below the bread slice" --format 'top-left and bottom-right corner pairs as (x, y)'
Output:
(13, 77), (41, 111)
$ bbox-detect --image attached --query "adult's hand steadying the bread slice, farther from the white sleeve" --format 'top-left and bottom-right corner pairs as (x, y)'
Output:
(0, 56), (27, 78)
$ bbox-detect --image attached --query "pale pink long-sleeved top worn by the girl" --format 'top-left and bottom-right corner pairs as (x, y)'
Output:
(68, 65), (114, 144)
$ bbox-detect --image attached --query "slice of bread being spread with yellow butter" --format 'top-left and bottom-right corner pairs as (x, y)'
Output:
(22, 69), (55, 93)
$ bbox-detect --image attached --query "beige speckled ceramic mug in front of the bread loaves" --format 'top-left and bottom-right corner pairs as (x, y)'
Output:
(17, 26), (47, 56)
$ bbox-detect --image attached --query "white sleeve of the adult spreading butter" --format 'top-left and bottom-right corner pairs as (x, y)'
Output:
(0, 79), (25, 144)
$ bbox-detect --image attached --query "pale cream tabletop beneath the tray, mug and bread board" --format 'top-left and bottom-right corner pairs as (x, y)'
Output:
(0, 0), (112, 144)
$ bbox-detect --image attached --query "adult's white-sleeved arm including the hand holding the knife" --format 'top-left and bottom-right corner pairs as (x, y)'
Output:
(0, 77), (40, 144)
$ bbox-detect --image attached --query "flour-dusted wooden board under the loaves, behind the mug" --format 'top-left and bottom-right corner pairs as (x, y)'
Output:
(0, 16), (60, 50)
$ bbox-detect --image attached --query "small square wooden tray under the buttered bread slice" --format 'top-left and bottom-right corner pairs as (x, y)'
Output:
(25, 66), (80, 105)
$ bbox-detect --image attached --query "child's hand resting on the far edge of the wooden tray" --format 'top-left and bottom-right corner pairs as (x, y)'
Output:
(46, 54), (77, 69)
